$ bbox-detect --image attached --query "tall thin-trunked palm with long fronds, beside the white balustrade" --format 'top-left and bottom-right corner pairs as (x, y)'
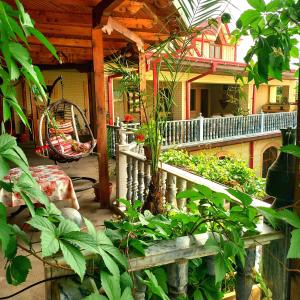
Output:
(107, 0), (230, 214)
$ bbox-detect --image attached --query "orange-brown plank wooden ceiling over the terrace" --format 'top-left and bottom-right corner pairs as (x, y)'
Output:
(7, 0), (177, 65)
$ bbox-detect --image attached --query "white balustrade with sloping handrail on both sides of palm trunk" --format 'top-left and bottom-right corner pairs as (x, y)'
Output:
(117, 139), (269, 209)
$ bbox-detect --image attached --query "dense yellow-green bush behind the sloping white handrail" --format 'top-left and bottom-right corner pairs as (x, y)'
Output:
(161, 149), (265, 198)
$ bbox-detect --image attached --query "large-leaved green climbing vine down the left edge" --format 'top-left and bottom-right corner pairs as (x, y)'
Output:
(0, 0), (131, 300)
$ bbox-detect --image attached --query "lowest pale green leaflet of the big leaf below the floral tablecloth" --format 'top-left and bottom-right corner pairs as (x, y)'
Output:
(59, 241), (86, 281)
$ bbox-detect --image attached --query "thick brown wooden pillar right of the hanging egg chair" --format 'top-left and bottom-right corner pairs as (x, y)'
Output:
(92, 28), (110, 208)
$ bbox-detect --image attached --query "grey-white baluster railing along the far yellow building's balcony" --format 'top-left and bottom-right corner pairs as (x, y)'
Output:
(108, 112), (297, 156)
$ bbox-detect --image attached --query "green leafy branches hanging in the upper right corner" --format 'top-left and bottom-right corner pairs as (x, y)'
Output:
(232, 0), (300, 87)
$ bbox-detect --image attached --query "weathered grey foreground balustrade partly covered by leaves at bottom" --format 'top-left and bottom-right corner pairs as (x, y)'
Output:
(45, 225), (283, 300)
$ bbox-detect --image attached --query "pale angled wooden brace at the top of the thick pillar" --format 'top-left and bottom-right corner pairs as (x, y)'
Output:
(102, 17), (144, 52)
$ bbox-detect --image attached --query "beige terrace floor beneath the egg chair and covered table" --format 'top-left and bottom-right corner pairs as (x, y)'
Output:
(0, 145), (115, 300)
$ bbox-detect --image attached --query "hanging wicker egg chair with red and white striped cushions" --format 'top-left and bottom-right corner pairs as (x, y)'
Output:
(35, 76), (96, 192)
